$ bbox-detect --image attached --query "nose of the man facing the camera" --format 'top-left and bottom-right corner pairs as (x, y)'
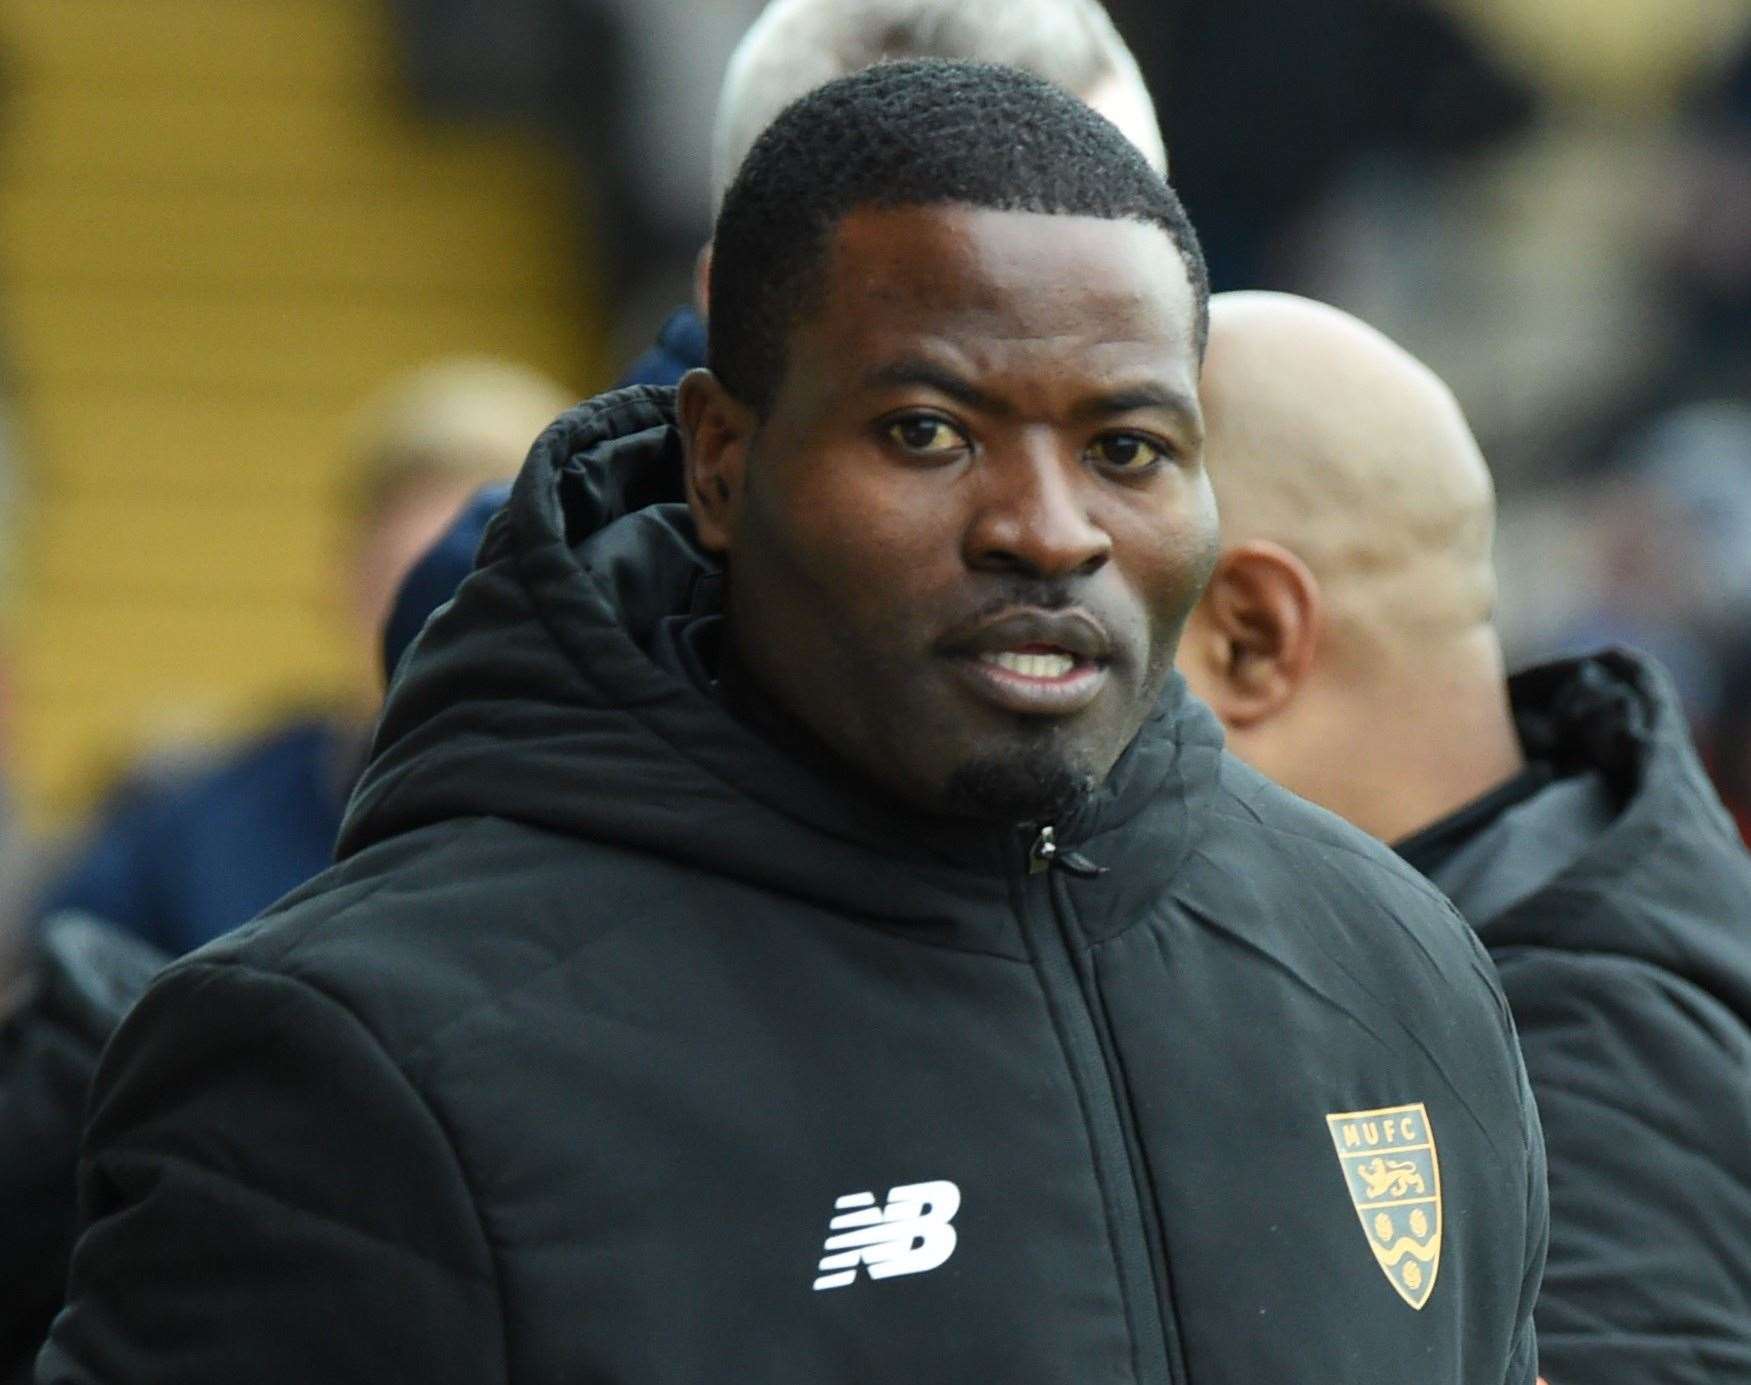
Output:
(965, 445), (1112, 578)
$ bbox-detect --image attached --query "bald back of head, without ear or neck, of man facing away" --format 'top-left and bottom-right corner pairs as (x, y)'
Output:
(1201, 292), (1495, 651)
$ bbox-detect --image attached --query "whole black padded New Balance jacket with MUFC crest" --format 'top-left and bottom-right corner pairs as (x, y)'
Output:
(40, 389), (1546, 1385)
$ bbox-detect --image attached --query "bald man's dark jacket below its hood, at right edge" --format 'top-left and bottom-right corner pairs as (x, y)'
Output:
(1497, 949), (1751, 1385)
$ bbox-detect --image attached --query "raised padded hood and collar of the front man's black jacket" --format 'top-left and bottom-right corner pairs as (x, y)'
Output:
(338, 385), (1220, 945)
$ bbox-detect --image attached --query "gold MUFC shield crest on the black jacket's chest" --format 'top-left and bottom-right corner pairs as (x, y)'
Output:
(1326, 1101), (1441, 1308)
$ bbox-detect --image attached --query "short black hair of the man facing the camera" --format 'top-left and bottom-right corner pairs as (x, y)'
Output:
(707, 60), (1210, 418)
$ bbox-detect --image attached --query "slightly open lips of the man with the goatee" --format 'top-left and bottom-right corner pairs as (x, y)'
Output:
(942, 611), (1112, 716)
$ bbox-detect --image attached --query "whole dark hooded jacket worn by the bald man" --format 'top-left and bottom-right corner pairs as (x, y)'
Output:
(1399, 651), (1751, 1385)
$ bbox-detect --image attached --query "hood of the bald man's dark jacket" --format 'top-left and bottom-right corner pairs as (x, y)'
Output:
(1474, 650), (1751, 1017)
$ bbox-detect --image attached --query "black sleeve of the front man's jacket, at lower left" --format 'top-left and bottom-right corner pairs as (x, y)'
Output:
(37, 961), (506, 1385)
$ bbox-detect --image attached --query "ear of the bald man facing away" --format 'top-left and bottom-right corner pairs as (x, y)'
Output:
(1178, 539), (1320, 730)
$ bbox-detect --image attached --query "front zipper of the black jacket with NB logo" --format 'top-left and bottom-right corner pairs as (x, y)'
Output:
(1019, 825), (1184, 1385)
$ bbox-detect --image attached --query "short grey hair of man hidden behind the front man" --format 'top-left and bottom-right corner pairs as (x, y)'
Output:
(711, 0), (1168, 205)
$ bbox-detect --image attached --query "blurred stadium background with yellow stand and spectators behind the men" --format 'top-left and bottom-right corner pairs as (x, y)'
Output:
(0, 0), (1751, 973)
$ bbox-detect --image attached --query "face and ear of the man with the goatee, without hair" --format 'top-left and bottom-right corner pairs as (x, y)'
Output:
(681, 207), (1217, 821)
